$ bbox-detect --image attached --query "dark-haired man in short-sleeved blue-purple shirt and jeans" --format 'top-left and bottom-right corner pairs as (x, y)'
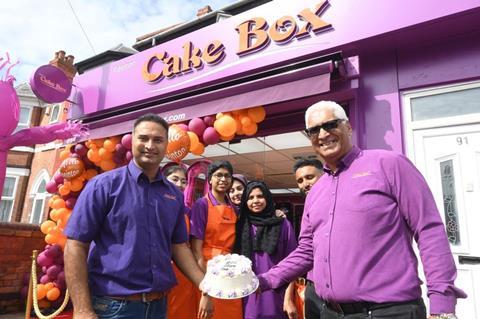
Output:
(65, 114), (213, 319)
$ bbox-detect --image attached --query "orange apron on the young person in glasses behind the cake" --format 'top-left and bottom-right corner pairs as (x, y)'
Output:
(202, 195), (243, 319)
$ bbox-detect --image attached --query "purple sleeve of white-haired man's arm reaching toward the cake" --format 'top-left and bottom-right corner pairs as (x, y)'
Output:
(258, 205), (313, 290)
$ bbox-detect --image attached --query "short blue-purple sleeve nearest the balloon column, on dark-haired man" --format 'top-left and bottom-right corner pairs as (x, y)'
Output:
(64, 176), (109, 243)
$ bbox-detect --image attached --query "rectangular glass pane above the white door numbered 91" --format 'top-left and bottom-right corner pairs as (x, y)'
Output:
(410, 86), (480, 121)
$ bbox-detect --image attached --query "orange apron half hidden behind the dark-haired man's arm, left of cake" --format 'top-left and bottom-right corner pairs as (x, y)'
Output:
(167, 215), (198, 319)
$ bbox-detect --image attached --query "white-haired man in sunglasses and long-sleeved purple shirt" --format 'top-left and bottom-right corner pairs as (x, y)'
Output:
(259, 101), (466, 319)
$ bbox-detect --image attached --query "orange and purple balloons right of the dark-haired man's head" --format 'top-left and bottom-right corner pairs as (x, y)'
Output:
(166, 106), (266, 162)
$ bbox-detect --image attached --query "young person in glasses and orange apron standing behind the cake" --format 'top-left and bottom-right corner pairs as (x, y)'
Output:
(190, 161), (242, 319)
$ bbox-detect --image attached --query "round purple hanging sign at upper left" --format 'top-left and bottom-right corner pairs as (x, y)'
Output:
(30, 64), (72, 103)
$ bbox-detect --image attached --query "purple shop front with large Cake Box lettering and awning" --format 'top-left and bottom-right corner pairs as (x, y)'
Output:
(69, 0), (480, 153)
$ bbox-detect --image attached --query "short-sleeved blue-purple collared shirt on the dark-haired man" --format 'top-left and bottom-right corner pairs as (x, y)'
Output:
(65, 161), (187, 296)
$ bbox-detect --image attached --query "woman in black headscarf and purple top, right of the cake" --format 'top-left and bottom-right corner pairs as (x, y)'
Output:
(234, 181), (297, 319)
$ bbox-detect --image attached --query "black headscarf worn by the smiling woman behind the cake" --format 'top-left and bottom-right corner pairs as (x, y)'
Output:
(234, 181), (284, 259)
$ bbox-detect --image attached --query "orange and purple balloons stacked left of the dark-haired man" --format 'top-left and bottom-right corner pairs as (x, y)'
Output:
(31, 134), (132, 308)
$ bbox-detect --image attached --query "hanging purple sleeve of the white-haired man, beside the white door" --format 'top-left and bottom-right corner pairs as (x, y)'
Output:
(383, 154), (466, 314)
